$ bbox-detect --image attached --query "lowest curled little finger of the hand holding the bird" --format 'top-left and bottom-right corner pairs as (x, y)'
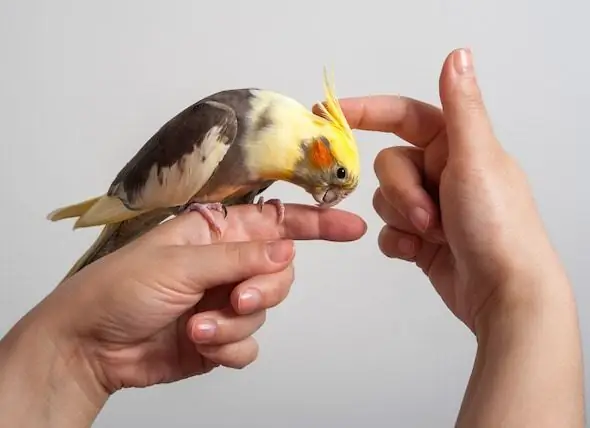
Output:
(196, 336), (258, 369)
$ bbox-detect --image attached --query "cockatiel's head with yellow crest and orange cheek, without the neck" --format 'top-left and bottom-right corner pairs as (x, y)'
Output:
(294, 71), (360, 207)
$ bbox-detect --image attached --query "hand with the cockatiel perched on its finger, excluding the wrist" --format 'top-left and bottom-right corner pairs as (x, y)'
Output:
(17, 205), (365, 402)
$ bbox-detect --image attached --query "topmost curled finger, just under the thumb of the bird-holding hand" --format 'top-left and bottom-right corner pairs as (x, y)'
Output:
(230, 264), (295, 315)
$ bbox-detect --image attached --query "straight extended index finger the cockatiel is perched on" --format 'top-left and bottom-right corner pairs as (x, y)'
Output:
(145, 204), (367, 245)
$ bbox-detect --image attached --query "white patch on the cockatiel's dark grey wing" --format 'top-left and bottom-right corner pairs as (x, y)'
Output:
(133, 126), (231, 210)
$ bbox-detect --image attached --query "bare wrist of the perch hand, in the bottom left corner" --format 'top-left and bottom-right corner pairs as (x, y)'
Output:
(0, 307), (108, 428)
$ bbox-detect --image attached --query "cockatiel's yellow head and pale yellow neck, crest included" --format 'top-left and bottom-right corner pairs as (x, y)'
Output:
(245, 69), (360, 206)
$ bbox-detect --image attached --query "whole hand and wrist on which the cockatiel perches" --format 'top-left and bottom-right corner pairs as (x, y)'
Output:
(0, 201), (366, 428)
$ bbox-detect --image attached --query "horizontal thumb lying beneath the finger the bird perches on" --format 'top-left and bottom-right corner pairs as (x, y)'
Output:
(177, 240), (294, 293)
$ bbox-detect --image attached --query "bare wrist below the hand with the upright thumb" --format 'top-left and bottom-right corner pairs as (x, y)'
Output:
(457, 267), (584, 428)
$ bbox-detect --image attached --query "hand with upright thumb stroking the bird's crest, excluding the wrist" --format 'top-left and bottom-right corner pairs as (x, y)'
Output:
(328, 50), (563, 330)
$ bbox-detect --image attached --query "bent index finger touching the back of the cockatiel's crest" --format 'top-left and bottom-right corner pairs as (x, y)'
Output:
(313, 95), (444, 147)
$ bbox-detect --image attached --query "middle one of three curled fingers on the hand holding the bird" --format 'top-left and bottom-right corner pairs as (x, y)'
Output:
(187, 308), (266, 345)
